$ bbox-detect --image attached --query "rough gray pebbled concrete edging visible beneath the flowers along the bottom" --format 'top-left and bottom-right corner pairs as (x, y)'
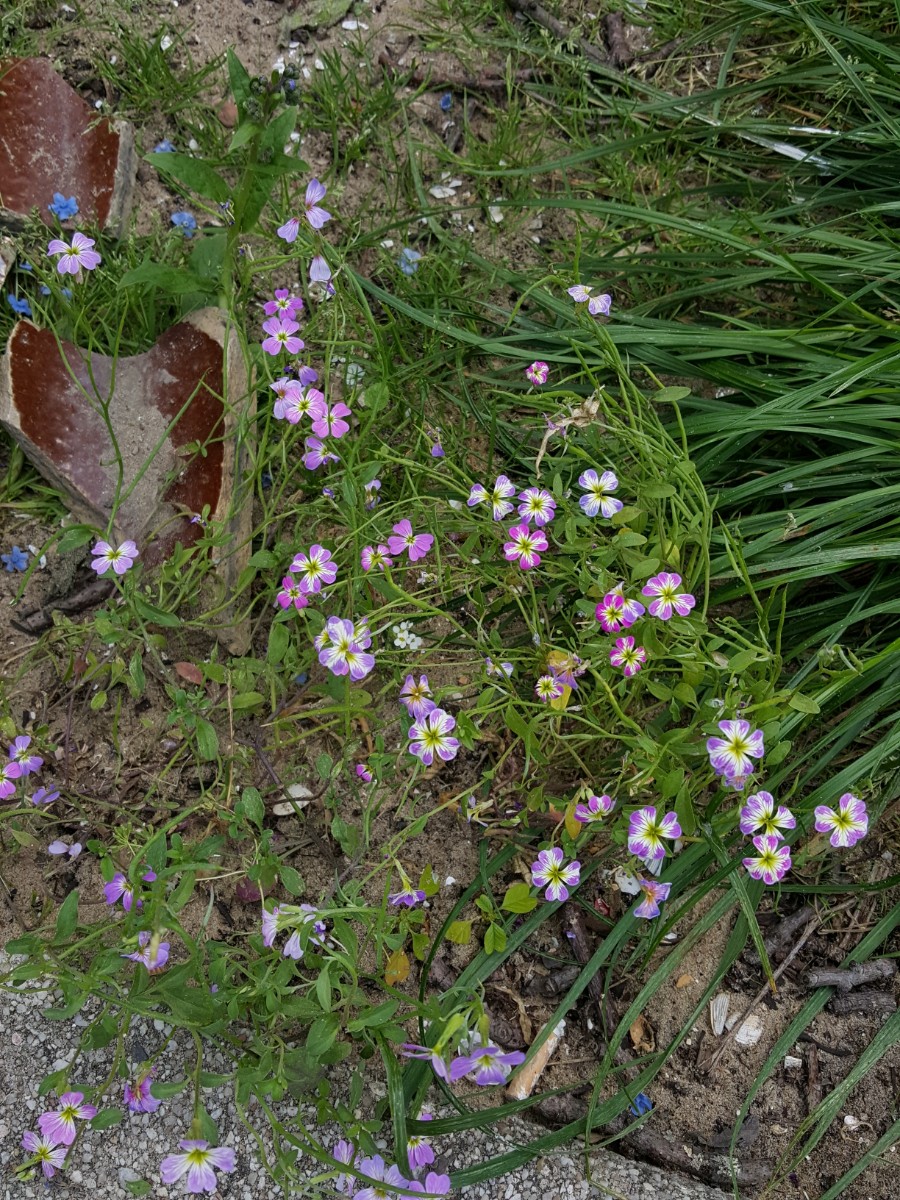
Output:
(0, 952), (727, 1200)
